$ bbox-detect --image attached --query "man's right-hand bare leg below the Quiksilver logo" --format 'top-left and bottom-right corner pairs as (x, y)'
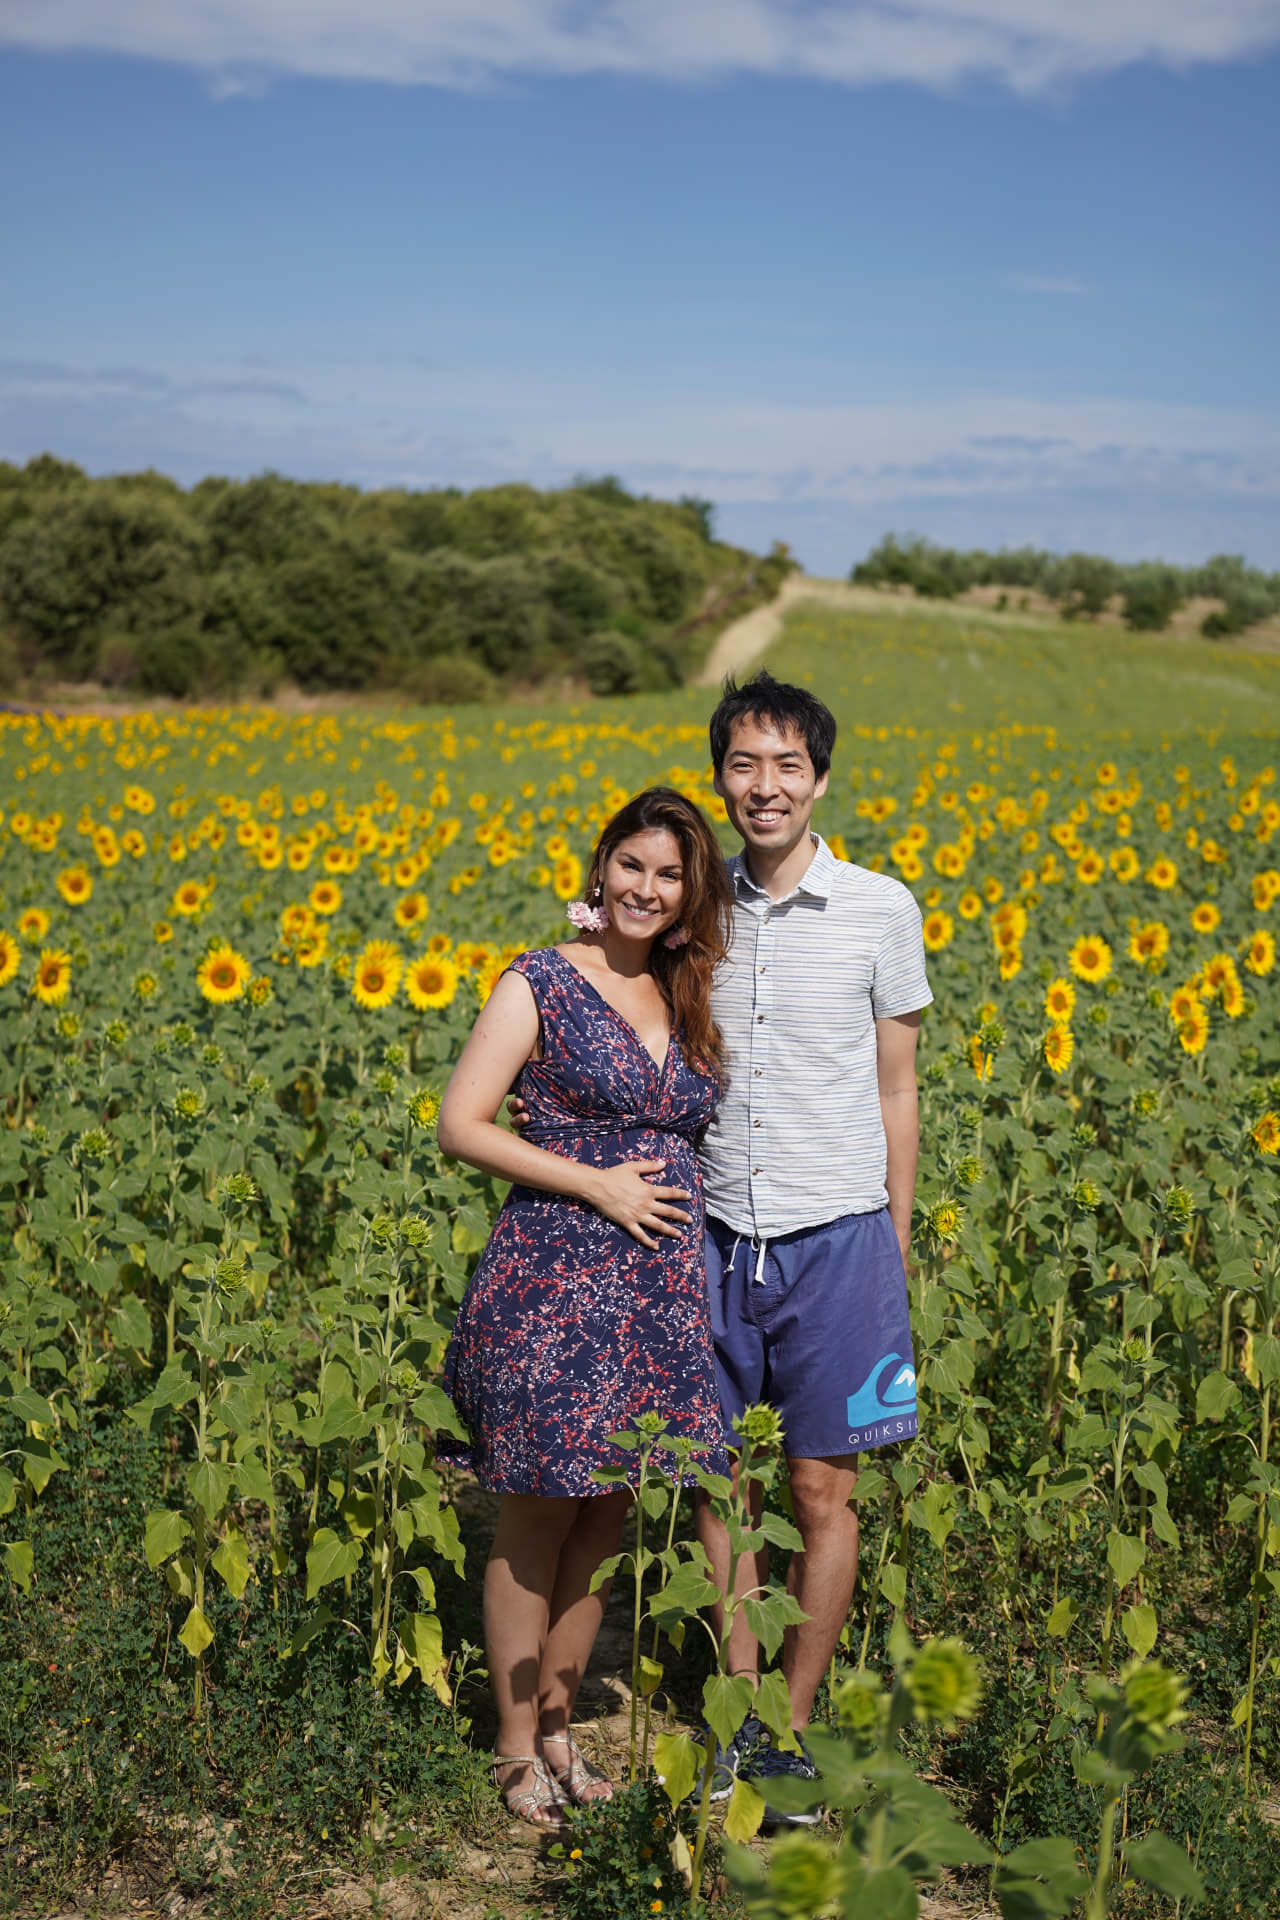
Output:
(783, 1453), (858, 1732)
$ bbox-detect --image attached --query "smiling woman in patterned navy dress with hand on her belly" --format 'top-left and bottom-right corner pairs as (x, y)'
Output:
(439, 787), (729, 1826)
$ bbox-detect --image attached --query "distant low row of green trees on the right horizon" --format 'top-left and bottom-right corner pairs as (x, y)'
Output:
(850, 534), (1280, 639)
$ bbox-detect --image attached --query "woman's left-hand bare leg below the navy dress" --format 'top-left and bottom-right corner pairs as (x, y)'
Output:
(484, 1494), (583, 1797)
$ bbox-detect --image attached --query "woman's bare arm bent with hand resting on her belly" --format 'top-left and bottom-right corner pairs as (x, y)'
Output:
(438, 972), (691, 1248)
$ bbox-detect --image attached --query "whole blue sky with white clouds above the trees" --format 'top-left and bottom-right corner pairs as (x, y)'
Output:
(0, 0), (1280, 572)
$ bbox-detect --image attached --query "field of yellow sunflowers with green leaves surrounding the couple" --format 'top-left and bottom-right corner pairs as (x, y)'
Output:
(0, 612), (1280, 1914)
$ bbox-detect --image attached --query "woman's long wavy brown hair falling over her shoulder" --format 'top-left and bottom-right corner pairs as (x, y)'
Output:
(587, 787), (733, 1079)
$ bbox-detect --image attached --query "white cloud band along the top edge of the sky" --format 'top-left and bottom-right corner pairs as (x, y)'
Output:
(0, 0), (1280, 98)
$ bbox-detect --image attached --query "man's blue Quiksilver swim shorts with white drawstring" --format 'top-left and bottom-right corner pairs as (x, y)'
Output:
(706, 1208), (919, 1459)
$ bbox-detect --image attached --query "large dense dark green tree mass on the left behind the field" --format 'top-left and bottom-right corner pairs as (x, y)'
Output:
(0, 455), (791, 701)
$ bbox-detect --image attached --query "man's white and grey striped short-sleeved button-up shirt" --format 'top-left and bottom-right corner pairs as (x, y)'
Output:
(700, 833), (933, 1240)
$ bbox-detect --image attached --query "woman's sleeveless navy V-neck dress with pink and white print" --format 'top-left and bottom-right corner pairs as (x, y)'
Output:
(439, 947), (727, 1496)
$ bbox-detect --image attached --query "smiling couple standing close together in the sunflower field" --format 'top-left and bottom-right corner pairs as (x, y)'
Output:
(439, 674), (931, 1826)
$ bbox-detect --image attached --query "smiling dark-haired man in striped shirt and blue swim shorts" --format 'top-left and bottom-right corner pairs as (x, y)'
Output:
(699, 672), (933, 1820)
